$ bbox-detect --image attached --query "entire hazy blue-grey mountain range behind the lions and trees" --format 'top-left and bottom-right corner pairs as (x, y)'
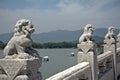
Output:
(0, 28), (119, 43)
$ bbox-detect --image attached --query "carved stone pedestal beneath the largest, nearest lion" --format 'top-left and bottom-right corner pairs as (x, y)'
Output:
(0, 58), (42, 80)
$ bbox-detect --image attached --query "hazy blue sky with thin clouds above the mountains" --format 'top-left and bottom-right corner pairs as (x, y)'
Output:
(0, 0), (120, 34)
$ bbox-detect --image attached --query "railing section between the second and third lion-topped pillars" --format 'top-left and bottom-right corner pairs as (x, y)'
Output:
(97, 51), (113, 80)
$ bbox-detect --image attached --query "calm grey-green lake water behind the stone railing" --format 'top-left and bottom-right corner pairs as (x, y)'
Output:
(0, 49), (77, 80)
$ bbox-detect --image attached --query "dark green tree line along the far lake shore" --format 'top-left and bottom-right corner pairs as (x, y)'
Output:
(0, 41), (104, 54)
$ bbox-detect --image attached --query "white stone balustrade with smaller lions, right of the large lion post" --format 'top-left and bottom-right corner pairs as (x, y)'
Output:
(46, 24), (120, 80)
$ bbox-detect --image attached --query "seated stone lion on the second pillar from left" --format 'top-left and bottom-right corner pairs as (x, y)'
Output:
(79, 24), (94, 43)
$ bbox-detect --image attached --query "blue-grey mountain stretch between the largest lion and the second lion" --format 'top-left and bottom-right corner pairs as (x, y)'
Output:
(32, 30), (83, 42)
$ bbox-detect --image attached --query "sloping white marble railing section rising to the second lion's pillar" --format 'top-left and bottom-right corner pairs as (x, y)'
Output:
(46, 62), (91, 80)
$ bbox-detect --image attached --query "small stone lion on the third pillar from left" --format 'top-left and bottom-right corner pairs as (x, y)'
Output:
(104, 26), (115, 43)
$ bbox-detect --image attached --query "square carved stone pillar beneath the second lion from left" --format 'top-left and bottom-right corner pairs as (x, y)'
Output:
(77, 42), (98, 80)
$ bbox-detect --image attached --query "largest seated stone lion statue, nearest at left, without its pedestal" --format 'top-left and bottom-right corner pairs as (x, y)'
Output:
(3, 19), (39, 59)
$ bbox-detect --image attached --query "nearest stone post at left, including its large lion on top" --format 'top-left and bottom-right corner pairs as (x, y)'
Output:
(0, 19), (42, 80)
